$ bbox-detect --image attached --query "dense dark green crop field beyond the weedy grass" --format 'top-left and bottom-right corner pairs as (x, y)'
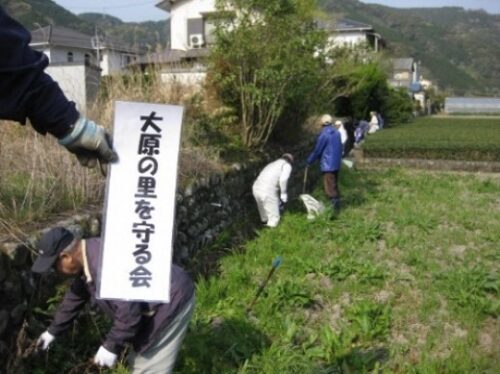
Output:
(363, 117), (500, 161)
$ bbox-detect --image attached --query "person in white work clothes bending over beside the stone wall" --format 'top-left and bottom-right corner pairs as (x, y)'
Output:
(252, 153), (293, 227)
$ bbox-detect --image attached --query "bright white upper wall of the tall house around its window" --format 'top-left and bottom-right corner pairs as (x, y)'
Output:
(170, 0), (215, 51)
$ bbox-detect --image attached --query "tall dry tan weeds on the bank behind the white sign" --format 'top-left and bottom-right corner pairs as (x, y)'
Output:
(0, 71), (242, 231)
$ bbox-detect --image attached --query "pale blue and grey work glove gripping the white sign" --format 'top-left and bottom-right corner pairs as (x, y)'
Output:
(59, 117), (118, 168)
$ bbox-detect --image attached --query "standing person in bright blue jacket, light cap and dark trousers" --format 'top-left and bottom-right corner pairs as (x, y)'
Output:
(307, 114), (342, 212)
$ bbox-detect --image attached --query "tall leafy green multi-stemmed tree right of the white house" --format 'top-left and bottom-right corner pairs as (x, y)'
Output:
(208, 0), (325, 147)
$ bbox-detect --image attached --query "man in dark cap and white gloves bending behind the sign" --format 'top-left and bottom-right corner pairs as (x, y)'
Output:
(32, 227), (194, 373)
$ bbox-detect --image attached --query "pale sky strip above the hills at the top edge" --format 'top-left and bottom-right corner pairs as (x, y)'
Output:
(54, 0), (500, 22)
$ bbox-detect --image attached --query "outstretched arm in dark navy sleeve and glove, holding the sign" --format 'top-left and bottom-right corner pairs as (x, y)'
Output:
(0, 6), (118, 167)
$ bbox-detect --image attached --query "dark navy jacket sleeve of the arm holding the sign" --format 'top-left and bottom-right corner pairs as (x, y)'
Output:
(0, 7), (79, 138)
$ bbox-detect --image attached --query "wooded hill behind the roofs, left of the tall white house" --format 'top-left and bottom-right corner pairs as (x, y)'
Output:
(0, 0), (168, 50)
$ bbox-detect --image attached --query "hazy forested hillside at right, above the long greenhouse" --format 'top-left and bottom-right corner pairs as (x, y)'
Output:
(319, 0), (500, 95)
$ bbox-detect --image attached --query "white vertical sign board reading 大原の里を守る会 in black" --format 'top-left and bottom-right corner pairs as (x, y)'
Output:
(97, 101), (183, 302)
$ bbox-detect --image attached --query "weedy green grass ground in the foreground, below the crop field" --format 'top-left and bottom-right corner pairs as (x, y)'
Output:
(17, 169), (500, 373)
